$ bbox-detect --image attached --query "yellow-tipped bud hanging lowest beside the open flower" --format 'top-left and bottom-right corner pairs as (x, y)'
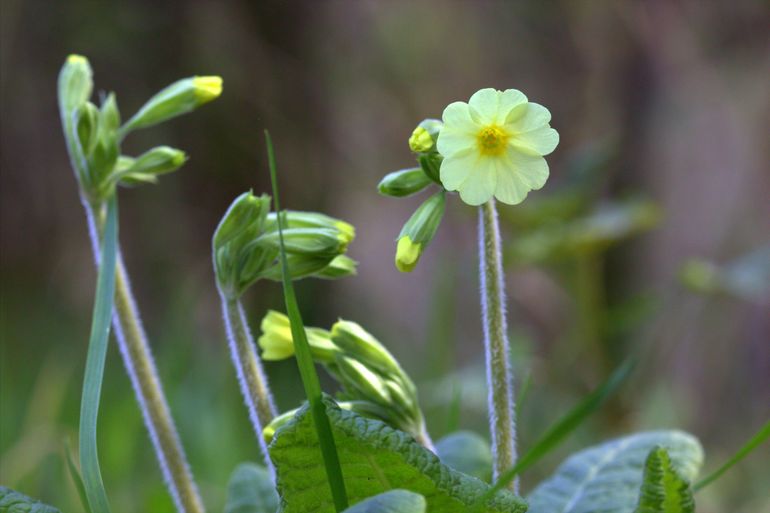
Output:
(395, 190), (446, 273)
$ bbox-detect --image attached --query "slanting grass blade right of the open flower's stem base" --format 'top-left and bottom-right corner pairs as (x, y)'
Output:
(481, 357), (636, 503)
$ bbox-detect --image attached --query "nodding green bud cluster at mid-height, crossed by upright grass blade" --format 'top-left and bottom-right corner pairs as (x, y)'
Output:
(212, 192), (356, 299)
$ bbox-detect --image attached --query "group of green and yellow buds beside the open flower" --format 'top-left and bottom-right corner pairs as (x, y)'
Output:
(377, 119), (446, 272)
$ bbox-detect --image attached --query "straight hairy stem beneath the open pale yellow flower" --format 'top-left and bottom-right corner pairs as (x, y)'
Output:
(479, 199), (519, 493)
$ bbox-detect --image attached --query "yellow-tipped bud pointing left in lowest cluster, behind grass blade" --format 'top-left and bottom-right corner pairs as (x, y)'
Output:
(257, 310), (340, 363)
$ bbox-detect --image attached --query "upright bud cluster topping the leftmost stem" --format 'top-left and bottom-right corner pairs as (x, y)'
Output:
(58, 55), (222, 204)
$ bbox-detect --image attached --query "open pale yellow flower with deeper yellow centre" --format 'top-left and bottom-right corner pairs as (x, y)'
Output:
(437, 89), (559, 205)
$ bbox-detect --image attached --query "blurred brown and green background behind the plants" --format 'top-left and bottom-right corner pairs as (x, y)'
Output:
(0, 0), (770, 513)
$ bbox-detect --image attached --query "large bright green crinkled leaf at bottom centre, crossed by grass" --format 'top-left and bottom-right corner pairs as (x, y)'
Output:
(269, 398), (527, 513)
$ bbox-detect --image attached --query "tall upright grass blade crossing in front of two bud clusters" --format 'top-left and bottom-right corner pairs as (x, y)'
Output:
(265, 130), (348, 513)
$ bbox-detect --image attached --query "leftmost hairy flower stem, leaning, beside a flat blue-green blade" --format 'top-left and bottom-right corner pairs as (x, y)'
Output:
(83, 199), (205, 513)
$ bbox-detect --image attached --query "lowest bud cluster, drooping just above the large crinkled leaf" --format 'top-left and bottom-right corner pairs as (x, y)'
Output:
(258, 311), (425, 439)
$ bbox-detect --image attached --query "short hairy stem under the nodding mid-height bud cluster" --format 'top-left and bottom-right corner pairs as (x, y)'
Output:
(220, 291), (278, 475)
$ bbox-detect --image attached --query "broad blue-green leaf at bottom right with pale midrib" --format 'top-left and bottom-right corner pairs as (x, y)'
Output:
(529, 431), (703, 513)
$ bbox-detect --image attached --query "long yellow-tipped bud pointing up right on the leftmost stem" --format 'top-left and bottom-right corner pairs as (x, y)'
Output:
(121, 76), (222, 135)
